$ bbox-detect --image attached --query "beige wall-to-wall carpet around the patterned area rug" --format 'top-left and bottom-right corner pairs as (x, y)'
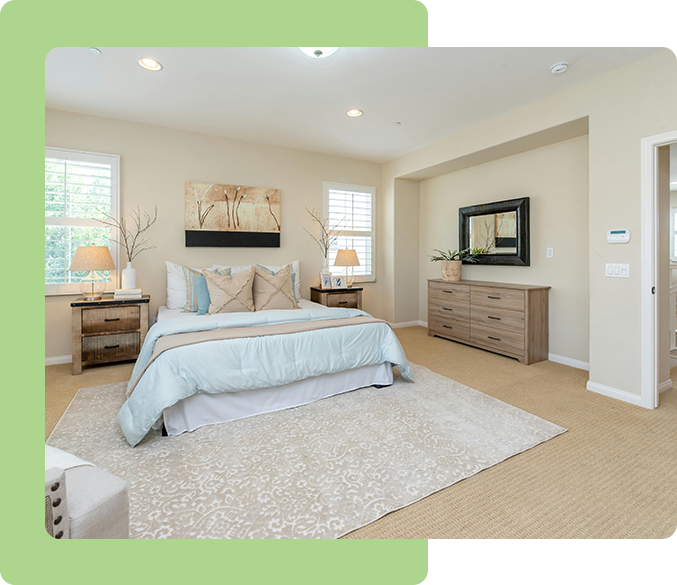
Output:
(45, 327), (677, 541)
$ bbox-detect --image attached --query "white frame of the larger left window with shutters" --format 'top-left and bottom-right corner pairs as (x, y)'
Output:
(45, 146), (122, 297)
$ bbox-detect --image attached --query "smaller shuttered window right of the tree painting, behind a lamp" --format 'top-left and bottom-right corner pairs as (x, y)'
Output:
(324, 183), (376, 282)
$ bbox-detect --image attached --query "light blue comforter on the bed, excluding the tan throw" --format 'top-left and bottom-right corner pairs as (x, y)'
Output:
(118, 308), (413, 447)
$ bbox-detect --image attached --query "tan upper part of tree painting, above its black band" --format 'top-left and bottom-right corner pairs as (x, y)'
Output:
(185, 181), (280, 233)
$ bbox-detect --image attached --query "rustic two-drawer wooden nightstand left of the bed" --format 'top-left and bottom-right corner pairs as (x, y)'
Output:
(71, 295), (150, 375)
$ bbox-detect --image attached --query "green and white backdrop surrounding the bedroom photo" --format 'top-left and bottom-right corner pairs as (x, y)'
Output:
(0, 0), (677, 583)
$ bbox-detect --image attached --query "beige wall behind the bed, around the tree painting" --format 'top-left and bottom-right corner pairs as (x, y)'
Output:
(45, 110), (382, 357)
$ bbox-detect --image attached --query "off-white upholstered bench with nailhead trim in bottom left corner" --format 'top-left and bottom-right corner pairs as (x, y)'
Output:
(45, 445), (129, 538)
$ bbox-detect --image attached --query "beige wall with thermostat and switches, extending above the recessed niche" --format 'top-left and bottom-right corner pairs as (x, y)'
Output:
(379, 49), (677, 395)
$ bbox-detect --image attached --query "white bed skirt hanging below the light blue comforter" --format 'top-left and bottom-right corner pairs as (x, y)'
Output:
(156, 362), (393, 435)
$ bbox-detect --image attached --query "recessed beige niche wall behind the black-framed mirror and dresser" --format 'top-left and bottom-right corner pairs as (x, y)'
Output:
(419, 136), (589, 362)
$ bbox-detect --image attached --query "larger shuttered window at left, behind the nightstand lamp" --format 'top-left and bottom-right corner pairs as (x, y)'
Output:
(45, 148), (119, 295)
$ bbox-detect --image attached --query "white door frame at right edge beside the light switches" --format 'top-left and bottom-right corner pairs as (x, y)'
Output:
(640, 130), (677, 408)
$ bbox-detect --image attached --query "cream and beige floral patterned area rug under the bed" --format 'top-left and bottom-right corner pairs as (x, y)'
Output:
(47, 365), (566, 538)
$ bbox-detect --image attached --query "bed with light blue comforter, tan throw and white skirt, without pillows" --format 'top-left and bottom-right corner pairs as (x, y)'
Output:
(118, 299), (413, 446)
